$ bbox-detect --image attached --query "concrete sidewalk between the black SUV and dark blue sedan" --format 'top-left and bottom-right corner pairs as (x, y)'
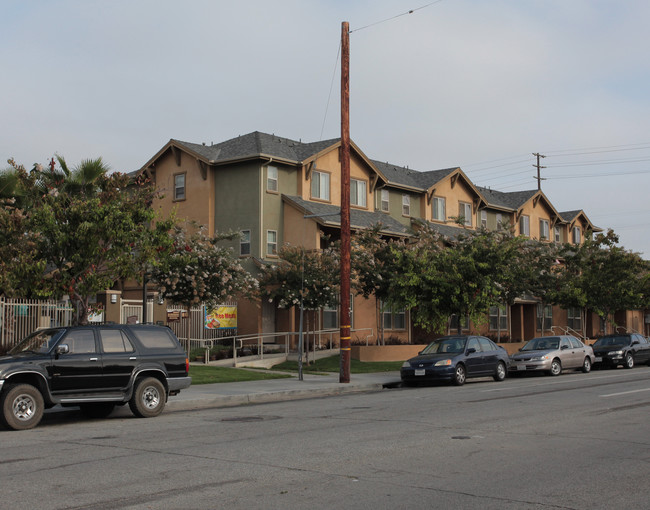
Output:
(166, 372), (400, 411)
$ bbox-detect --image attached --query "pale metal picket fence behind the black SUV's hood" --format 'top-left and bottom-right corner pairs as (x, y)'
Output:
(0, 297), (74, 349)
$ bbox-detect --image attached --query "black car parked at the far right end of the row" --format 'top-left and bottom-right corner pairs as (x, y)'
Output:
(592, 333), (650, 368)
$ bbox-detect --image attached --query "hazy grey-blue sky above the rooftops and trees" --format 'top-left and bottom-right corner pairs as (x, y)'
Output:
(5, 0), (650, 258)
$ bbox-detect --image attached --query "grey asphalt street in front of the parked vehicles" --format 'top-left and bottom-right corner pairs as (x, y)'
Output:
(0, 367), (650, 509)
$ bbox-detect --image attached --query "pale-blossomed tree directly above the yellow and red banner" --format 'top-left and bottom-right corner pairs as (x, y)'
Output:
(151, 226), (258, 342)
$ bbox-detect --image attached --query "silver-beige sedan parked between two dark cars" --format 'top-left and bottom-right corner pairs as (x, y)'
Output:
(508, 335), (595, 375)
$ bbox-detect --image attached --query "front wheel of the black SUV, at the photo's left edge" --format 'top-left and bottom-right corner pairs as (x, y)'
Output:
(0, 384), (44, 430)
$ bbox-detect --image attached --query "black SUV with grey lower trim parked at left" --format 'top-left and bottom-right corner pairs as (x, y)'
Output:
(0, 324), (192, 430)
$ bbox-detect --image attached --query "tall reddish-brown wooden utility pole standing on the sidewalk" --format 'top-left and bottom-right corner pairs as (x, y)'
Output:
(339, 21), (351, 383)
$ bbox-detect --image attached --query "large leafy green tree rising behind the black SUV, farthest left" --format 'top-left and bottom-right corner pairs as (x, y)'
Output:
(0, 157), (173, 324)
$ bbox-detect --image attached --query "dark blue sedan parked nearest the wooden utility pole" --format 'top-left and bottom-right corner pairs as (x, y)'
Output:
(400, 335), (508, 386)
